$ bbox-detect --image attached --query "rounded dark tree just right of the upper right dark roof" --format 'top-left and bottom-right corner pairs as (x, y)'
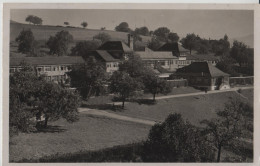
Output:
(181, 33), (199, 54)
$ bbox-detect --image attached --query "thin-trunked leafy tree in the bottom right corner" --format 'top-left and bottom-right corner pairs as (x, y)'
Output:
(201, 99), (253, 162)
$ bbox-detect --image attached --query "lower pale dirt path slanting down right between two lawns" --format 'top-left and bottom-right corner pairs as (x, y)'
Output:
(78, 108), (156, 126)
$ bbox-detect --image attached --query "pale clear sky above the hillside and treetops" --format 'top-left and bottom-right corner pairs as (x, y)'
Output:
(11, 9), (254, 42)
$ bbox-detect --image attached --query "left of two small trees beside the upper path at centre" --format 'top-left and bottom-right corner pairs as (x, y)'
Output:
(109, 71), (141, 108)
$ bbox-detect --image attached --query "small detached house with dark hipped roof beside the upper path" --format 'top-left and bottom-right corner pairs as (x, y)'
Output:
(174, 62), (230, 90)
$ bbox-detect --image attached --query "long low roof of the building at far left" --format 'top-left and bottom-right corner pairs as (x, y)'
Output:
(10, 56), (85, 66)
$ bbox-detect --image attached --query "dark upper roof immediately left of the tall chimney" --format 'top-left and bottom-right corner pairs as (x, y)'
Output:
(98, 41), (133, 53)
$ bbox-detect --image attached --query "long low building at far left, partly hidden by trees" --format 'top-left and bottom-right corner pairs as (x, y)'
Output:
(10, 56), (85, 83)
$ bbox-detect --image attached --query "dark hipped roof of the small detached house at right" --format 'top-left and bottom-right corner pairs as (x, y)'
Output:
(176, 62), (229, 77)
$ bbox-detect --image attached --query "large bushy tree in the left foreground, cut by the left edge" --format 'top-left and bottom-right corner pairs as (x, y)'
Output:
(9, 63), (79, 132)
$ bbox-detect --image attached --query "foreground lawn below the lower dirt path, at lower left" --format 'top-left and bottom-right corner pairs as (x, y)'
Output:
(9, 114), (151, 162)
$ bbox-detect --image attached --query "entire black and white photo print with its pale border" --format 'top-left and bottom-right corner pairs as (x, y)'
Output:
(3, 4), (258, 164)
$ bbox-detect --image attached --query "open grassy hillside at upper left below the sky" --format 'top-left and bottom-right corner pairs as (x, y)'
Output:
(10, 20), (150, 42)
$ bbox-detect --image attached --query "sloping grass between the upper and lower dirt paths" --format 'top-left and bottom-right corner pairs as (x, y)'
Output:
(104, 92), (247, 126)
